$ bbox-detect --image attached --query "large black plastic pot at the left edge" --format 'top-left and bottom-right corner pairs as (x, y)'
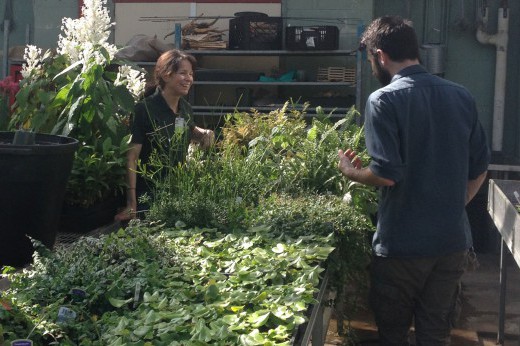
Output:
(0, 132), (78, 267)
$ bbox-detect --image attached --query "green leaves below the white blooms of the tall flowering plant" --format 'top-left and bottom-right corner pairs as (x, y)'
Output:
(10, 47), (134, 206)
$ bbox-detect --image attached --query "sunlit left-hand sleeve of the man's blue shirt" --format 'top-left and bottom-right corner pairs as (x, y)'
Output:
(365, 93), (404, 182)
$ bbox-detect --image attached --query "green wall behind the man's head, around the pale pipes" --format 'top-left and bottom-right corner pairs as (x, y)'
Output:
(372, 0), (520, 158)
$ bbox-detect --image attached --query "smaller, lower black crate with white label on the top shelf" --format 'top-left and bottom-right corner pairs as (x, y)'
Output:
(285, 25), (339, 50)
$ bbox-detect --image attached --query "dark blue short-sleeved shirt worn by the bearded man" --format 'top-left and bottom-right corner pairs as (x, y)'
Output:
(365, 65), (490, 257)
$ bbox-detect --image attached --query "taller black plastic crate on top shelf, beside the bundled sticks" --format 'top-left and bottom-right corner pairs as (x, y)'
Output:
(229, 16), (282, 50)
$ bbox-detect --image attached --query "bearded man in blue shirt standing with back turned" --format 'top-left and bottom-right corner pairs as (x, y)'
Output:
(338, 16), (490, 345)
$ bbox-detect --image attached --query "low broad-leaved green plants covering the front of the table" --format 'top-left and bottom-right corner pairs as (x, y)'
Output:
(0, 224), (333, 345)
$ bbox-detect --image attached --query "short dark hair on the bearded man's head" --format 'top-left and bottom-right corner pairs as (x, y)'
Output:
(360, 16), (420, 62)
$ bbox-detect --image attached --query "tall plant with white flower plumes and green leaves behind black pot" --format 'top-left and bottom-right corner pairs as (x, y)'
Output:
(10, 0), (145, 206)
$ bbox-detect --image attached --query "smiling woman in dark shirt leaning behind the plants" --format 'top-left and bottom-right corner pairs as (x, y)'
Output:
(115, 49), (214, 221)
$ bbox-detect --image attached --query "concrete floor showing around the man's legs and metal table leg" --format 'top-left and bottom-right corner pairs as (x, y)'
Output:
(326, 252), (520, 346)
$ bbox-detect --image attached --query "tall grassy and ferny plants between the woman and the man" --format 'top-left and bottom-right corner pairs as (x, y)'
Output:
(147, 105), (375, 230)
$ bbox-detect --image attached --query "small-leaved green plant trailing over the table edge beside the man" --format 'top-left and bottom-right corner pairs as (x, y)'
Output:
(247, 194), (373, 290)
